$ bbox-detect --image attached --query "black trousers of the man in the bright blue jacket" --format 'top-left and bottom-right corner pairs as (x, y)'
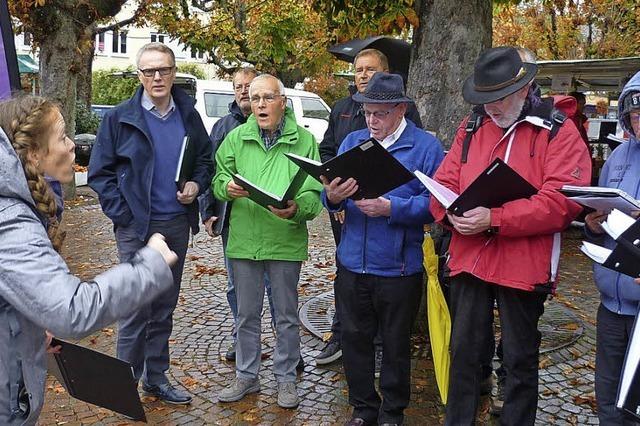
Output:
(336, 265), (424, 424)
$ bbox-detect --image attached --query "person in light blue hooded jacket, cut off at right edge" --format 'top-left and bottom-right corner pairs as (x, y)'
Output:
(585, 72), (640, 425)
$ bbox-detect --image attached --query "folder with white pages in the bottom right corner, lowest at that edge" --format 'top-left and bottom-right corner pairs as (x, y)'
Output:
(616, 314), (640, 421)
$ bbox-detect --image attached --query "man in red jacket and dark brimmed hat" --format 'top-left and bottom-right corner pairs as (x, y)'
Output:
(430, 47), (591, 425)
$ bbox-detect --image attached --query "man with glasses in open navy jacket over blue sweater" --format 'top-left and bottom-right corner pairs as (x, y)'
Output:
(88, 43), (213, 404)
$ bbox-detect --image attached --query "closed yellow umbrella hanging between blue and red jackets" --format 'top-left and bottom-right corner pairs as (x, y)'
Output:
(422, 236), (451, 404)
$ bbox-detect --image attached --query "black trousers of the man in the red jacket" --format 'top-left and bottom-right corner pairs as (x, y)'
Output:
(445, 274), (546, 426)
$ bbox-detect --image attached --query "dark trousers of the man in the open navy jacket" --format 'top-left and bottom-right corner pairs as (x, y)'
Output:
(115, 215), (189, 385)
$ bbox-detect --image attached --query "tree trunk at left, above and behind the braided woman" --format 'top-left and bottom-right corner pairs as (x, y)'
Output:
(40, 13), (79, 200)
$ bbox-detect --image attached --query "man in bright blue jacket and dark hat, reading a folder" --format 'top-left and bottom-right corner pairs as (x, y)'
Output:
(323, 73), (444, 426)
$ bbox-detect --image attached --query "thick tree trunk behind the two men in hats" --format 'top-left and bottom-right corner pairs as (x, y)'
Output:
(408, 0), (492, 147)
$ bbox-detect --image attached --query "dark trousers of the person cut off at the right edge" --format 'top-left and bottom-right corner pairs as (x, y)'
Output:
(596, 304), (638, 426)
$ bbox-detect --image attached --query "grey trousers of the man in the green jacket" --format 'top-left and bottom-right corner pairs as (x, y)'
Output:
(229, 259), (302, 383)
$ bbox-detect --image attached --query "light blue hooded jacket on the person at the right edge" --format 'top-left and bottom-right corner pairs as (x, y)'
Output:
(585, 72), (640, 315)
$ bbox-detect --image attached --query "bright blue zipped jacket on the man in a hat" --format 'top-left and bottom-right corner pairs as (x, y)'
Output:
(322, 120), (444, 277)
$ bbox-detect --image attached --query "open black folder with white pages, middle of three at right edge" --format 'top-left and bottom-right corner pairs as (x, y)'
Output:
(580, 209), (640, 278)
